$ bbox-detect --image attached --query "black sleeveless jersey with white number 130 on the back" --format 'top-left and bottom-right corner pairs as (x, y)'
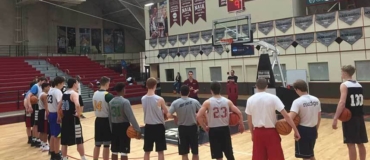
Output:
(343, 80), (364, 116)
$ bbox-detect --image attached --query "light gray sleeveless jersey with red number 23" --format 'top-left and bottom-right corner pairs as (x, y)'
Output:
(207, 97), (230, 128)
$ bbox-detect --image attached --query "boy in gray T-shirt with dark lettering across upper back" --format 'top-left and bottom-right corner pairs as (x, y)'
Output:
(167, 85), (201, 160)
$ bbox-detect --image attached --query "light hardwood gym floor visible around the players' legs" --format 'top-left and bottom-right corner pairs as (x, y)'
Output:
(0, 105), (370, 160)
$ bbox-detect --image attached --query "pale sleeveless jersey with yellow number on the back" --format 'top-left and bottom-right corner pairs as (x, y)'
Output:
(92, 90), (109, 118)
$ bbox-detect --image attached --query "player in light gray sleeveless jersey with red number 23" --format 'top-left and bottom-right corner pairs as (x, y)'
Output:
(197, 82), (244, 160)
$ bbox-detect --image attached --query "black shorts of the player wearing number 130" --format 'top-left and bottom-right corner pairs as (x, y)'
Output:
(342, 115), (368, 144)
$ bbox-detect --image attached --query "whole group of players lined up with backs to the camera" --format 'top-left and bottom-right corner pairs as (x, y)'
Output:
(25, 65), (368, 160)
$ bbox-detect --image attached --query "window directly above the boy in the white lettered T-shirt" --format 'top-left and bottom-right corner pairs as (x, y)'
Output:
(308, 62), (329, 81)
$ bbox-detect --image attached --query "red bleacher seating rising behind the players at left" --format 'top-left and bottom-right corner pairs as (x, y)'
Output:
(0, 56), (146, 113)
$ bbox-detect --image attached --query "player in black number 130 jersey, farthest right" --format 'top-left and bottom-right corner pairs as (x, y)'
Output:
(333, 65), (368, 160)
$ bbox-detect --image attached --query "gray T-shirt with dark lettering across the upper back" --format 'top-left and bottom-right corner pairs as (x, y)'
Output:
(169, 98), (201, 126)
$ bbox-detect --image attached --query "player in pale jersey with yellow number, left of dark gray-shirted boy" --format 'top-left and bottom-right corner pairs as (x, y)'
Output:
(92, 76), (113, 160)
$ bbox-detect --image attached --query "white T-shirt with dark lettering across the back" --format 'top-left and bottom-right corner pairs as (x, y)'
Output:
(290, 94), (321, 127)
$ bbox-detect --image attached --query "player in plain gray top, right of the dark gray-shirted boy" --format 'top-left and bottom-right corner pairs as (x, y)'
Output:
(141, 77), (168, 160)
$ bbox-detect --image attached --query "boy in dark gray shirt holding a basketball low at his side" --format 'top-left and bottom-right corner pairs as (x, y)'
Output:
(109, 83), (141, 160)
